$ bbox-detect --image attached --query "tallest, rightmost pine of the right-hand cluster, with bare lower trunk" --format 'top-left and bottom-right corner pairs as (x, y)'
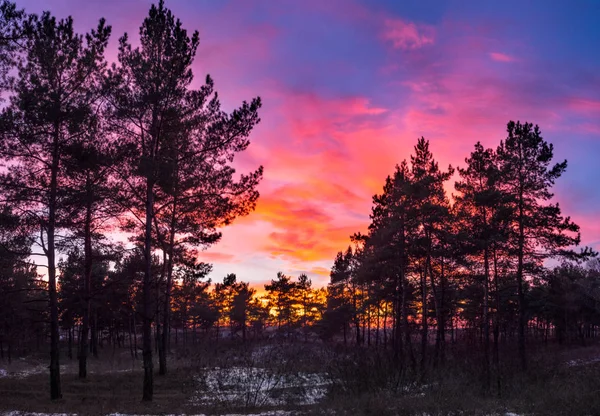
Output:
(497, 121), (587, 369)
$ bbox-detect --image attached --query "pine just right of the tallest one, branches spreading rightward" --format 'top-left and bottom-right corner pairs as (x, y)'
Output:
(155, 69), (262, 374)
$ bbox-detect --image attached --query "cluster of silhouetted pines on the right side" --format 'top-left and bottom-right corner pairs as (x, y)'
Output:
(325, 132), (600, 390)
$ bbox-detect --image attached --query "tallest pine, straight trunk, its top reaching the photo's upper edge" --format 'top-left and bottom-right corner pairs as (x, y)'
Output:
(106, 0), (206, 401)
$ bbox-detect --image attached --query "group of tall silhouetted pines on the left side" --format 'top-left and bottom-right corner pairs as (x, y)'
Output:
(0, 1), (262, 400)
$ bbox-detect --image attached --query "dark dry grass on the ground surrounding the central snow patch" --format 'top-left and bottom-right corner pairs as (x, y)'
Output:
(0, 344), (600, 416)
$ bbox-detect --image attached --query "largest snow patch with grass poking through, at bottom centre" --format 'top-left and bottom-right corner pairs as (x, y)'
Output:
(191, 367), (330, 407)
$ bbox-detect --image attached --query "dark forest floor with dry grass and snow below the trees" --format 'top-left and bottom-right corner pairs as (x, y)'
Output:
(0, 343), (600, 416)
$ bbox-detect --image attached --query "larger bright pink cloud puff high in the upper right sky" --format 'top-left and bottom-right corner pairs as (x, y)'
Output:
(382, 19), (435, 50)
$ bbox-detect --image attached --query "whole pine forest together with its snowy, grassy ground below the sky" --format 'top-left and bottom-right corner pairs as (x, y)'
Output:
(0, 0), (600, 415)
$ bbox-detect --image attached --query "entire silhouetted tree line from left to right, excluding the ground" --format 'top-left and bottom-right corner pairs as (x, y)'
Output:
(0, 0), (600, 401)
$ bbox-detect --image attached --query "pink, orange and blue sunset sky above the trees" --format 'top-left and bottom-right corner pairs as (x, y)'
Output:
(18, 0), (600, 285)
